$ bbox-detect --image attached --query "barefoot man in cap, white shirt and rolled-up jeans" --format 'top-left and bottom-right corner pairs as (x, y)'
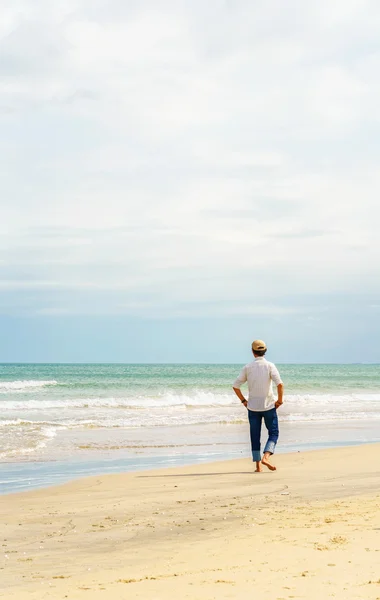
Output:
(233, 340), (284, 473)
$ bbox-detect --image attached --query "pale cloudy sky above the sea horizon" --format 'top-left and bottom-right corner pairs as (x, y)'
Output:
(0, 0), (380, 363)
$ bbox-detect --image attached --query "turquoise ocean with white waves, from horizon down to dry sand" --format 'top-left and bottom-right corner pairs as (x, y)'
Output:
(0, 364), (380, 493)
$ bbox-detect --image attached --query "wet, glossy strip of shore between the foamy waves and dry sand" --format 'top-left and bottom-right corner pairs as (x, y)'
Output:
(0, 420), (380, 496)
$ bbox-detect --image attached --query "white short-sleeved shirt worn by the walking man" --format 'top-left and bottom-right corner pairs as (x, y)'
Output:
(233, 356), (282, 411)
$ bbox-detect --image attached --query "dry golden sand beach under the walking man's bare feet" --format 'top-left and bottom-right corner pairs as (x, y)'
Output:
(0, 445), (380, 600)
